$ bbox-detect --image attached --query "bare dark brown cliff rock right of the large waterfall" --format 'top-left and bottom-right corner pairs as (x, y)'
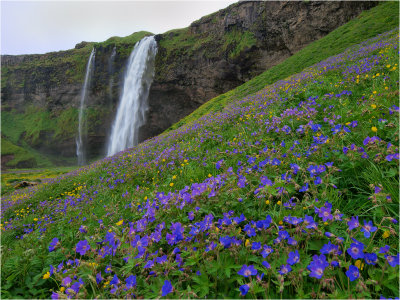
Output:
(142, 1), (376, 139)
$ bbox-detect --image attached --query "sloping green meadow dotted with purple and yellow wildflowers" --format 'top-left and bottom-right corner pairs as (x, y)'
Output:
(1, 30), (399, 299)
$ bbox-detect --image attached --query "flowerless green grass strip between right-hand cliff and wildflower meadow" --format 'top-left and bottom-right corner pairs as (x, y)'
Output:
(169, 1), (399, 130)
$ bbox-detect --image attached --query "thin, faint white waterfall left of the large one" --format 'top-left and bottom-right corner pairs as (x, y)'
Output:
(76, 48), (96, 166)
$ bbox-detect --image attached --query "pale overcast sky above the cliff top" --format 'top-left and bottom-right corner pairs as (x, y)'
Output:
(1, 0), (237, 54)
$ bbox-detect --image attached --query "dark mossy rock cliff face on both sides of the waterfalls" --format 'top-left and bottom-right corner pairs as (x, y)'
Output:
(1, 1), (377, 163)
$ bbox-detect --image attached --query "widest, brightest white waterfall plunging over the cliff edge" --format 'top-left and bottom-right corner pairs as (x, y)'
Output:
(107, 36), (157, 156)
